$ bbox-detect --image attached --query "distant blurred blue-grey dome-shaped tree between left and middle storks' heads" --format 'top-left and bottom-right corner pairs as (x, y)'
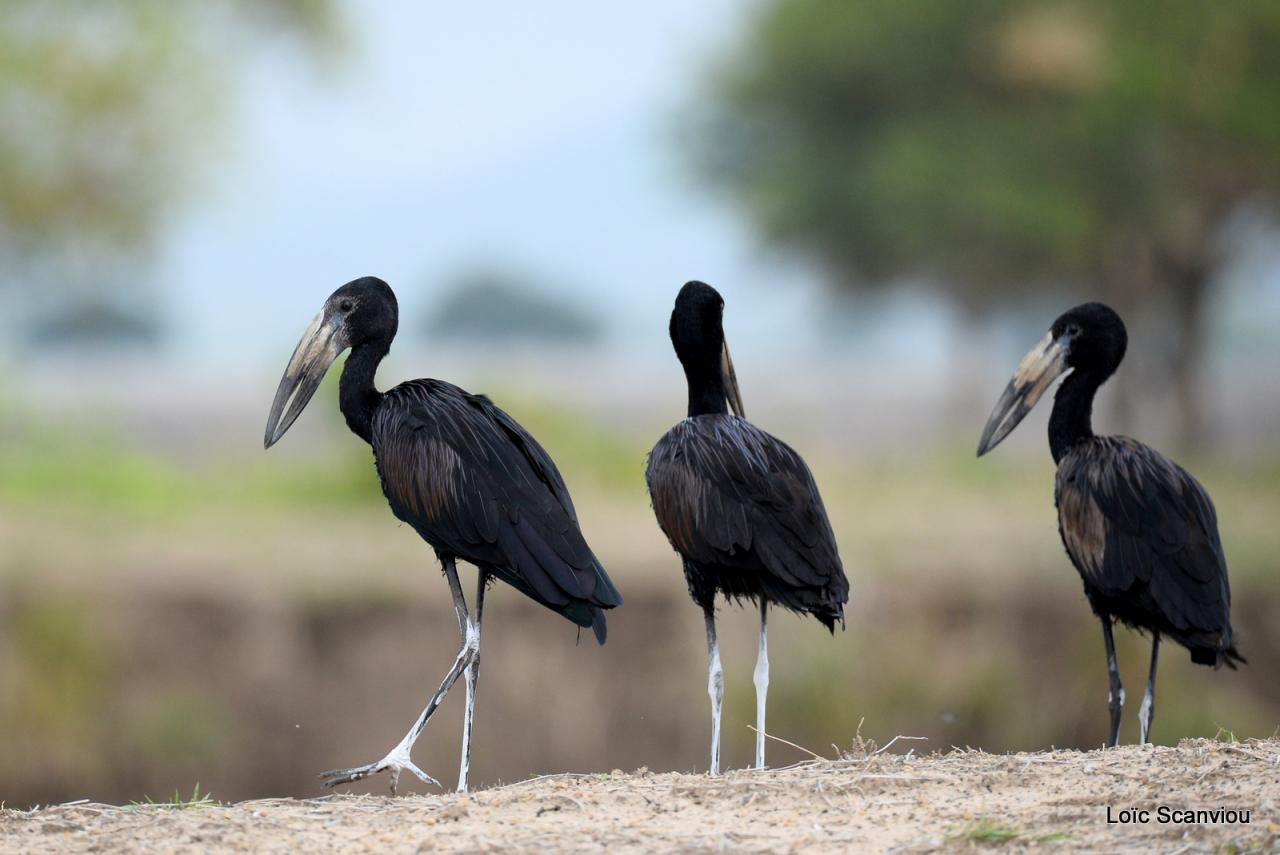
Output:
(424, 270), (600, 344)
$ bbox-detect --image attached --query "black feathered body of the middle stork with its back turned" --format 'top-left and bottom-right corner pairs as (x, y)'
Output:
(645, 415), (849, 626)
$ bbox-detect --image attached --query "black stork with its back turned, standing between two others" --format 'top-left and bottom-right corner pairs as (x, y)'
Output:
(645, 282), (849, 774)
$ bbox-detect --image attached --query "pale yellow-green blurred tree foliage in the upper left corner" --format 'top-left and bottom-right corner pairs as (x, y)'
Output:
(0, 0), (339, 343)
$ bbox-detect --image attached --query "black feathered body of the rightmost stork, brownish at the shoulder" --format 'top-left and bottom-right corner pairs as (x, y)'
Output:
(1056, 436), (1243, 667)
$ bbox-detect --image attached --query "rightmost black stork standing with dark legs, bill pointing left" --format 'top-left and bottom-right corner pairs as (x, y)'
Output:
(978, 303), (1244, 746)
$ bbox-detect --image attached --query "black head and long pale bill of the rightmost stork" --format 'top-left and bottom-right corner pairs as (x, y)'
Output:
(978, 303), (1129, 457)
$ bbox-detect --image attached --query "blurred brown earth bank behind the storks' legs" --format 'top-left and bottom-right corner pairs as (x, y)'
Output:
(0, 568), (1280, 808)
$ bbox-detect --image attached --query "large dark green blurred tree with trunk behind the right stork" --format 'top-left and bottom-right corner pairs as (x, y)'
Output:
(695, 0), (1280, 442)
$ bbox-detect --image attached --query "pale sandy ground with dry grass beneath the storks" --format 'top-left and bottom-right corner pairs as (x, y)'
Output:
(0, 740), (1280, 854)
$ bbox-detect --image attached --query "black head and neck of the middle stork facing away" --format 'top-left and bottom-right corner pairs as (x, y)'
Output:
(668, 282), (744, 417)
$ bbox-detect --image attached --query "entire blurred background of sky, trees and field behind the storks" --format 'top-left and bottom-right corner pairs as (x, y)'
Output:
(0, 0), (1280, 805)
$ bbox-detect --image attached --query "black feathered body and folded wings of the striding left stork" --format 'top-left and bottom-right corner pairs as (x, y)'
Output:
(372, 380), (622, 641)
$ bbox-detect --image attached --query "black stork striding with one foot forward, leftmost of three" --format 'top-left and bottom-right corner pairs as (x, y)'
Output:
(264, 276), (622, 794)
